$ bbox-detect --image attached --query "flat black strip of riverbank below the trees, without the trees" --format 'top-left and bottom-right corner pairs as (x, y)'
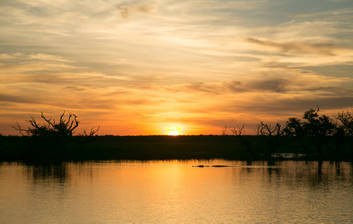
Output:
(0, 135), (353, 161)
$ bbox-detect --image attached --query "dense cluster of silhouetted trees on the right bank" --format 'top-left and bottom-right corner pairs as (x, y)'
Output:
(249, 107), (353, 161)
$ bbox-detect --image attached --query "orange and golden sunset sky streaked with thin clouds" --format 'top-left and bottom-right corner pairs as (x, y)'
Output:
(0, 0), (353, 135)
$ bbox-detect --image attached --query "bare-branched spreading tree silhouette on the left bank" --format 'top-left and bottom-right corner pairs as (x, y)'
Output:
(14, 112), (79, 137)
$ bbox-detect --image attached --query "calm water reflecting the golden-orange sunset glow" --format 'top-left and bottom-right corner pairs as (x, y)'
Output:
(0, 160), (353, 224)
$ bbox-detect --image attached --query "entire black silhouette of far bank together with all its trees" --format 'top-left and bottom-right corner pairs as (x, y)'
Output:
(0, 108), (353, 162)
